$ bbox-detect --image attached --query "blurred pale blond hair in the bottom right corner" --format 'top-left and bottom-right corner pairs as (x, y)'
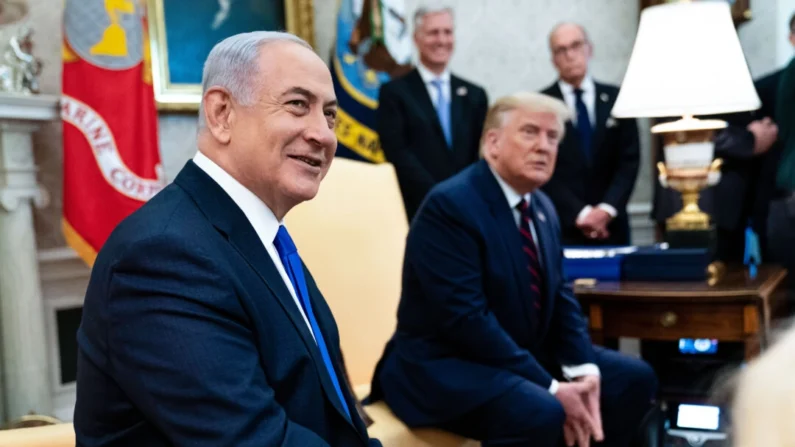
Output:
(732, 326), (795, 447)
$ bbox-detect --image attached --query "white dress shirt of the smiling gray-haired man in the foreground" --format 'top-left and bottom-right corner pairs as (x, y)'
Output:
(193, 152), (315, 337)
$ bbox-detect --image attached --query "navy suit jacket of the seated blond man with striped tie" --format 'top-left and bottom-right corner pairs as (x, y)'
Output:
(371, 160), (594, 426)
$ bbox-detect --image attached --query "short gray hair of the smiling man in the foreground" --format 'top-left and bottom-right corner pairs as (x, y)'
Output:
(199, 31), (312, 129)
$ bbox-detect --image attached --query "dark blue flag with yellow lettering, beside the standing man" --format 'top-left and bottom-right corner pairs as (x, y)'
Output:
(331, 0), (412, 163)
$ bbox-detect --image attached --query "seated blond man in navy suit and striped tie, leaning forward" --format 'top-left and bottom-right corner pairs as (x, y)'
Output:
(372, 93), (656, 447)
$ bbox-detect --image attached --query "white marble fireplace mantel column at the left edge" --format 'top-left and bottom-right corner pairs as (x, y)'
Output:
(0, 93), (59, 420)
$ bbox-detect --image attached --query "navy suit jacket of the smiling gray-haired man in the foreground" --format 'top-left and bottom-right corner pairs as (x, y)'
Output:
(74, 161), (380, 447)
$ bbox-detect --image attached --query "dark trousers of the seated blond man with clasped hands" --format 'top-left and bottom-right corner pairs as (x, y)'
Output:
(440, 346), (657, 447)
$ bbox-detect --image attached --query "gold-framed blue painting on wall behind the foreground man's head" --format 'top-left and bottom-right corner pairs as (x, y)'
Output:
(146, 0), (314, 111)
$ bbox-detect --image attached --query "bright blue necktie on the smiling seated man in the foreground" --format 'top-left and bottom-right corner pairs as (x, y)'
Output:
(273, 225), (351, 421)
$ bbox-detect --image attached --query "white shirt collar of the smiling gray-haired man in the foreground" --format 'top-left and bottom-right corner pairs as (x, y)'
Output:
(193, 152), (282, 246)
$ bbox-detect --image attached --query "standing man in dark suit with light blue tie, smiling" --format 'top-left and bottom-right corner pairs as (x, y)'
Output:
(376, 8), (488, 222)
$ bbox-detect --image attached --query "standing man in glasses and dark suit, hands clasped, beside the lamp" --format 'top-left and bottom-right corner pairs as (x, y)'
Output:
(543, 23), (640, 245)
